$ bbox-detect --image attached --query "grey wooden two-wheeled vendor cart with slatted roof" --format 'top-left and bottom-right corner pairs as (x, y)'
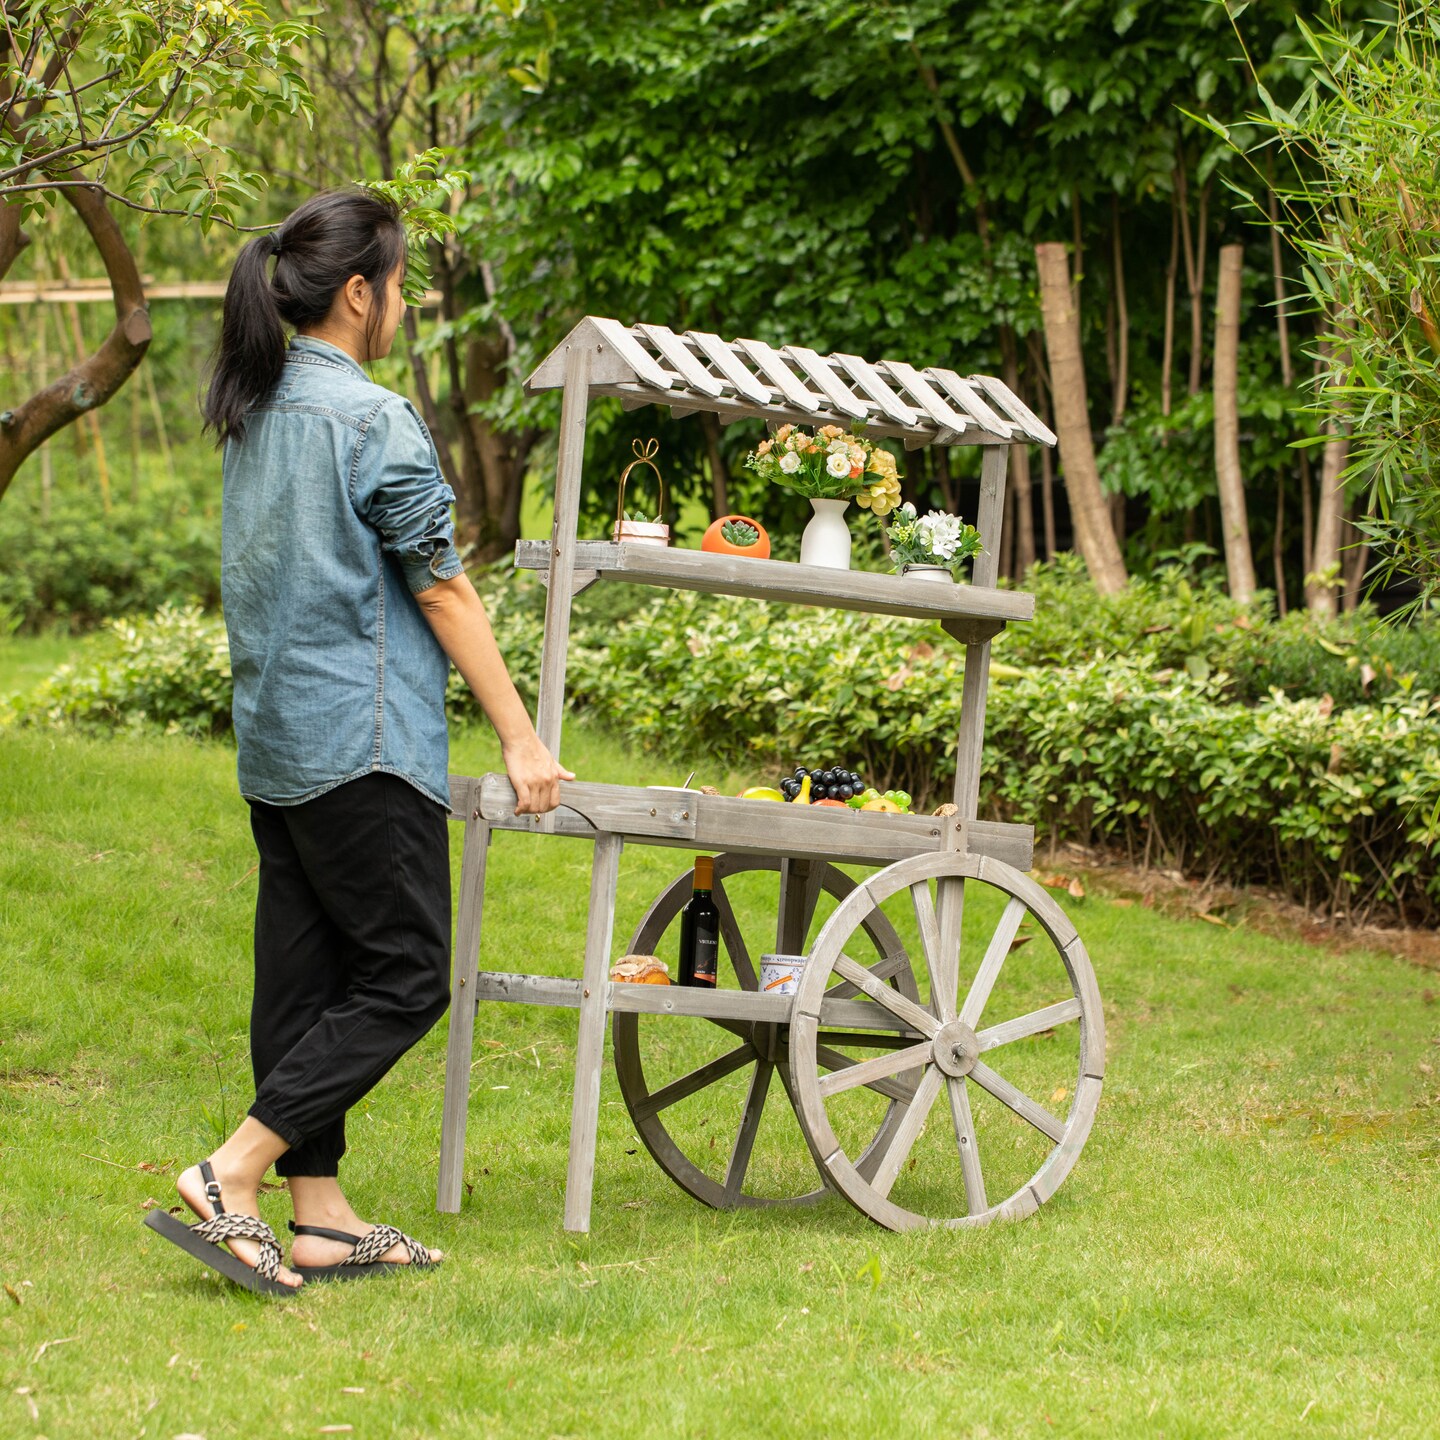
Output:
(438, 317), (1104, 1231)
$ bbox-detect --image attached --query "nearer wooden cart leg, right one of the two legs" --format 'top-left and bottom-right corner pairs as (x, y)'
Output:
(564, 834), (625, 1234)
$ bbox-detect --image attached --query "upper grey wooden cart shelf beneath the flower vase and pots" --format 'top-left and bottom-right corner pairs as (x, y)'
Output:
(516, 540), (1035, 644)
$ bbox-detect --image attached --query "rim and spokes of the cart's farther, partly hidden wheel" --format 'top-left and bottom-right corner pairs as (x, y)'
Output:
(612, 854), (919, 1210)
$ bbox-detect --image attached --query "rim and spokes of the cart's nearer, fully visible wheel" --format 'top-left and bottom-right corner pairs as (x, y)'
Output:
(791, 852), (1104, 1230)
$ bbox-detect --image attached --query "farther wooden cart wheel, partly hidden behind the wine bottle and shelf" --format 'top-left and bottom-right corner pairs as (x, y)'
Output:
(612, 854), (919, 1208)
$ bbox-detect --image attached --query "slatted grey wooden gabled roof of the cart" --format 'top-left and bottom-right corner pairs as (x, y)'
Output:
(526, 315), (1056, 449)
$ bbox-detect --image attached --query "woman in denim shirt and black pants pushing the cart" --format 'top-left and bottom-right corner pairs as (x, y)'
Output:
(147, 192), (575, 1293)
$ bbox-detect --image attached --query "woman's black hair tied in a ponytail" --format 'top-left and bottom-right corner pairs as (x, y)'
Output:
(202, 190), (405, 442)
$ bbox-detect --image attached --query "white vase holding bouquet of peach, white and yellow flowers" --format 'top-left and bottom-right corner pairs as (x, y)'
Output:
(744, 425), (900, 570)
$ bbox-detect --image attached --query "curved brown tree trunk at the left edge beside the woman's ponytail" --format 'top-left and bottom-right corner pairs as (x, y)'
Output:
(0, 186), (151, 498)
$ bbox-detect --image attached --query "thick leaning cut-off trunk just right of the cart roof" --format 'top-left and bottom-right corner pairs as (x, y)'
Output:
(1035, 243), (1126, 595)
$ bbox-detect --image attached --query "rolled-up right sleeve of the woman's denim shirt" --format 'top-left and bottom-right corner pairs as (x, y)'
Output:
(350, 396), (465, 595)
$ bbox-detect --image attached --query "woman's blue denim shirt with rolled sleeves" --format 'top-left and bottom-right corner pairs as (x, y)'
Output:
(220, 336), (462, 805)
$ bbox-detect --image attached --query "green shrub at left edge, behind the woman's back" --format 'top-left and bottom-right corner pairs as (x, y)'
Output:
(0, 481), (220, 632)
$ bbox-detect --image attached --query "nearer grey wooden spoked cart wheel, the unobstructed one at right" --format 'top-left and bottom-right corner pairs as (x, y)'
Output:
(791, 852), (1104, 1230)
